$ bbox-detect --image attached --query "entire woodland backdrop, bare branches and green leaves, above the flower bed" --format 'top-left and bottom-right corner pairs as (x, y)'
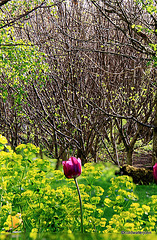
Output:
(0, 0), (157, 169)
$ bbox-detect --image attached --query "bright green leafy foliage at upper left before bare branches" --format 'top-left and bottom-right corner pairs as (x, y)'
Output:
(0, 27), (49, 118)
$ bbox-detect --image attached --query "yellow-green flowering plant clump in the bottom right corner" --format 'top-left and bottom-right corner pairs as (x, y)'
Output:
(104, 176), (157, 233)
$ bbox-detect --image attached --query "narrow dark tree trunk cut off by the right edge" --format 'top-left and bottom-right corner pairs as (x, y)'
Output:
(152, 90), (157, 165)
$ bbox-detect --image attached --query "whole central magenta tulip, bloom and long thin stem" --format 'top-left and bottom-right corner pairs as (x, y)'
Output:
(62, 157), (83, 233)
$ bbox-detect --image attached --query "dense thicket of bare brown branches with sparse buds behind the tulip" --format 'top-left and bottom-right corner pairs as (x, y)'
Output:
(0, 1), (156, 167)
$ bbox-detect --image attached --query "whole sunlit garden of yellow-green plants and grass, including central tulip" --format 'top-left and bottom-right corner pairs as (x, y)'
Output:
(0, 135), (157, 240)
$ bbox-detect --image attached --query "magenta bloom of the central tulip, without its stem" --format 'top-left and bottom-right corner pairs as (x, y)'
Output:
(62, 157), (82, 178)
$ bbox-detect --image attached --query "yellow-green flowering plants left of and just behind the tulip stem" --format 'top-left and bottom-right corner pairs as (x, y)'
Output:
(0, 136), (109, 232)
